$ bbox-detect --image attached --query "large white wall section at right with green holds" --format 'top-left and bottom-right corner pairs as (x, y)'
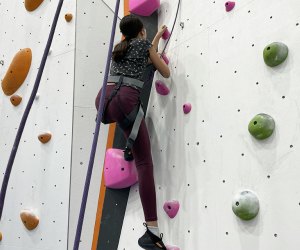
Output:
(118, 0), (300, 250)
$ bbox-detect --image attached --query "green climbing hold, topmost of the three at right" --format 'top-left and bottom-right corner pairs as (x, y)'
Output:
(263, 42), (289, 67)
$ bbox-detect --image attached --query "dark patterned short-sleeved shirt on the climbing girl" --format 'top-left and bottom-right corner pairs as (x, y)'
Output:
(110, 38), (152, 81)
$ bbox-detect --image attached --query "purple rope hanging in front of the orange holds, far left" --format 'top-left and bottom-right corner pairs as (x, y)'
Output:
(0, 0), (64, 220)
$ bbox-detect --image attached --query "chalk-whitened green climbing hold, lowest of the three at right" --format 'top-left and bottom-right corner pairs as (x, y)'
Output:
(232, 190), (259, 220)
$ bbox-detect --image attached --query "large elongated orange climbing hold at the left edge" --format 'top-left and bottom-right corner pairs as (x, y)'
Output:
(2, 48), (32, 95)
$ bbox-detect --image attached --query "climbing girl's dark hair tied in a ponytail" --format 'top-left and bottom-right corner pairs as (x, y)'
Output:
(112, 15), (144, 62)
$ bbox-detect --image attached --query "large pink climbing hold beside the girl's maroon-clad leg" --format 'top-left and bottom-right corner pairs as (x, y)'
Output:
(104, 148), (138, 189)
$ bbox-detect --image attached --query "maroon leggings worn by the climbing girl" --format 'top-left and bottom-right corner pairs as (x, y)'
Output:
(96, 85), (157, 221)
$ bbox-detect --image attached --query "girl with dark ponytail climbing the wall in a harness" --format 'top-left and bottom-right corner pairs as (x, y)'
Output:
(96, 15), (170, 250)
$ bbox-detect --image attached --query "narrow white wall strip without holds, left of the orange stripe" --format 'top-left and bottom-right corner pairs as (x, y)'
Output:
(68, 1), (123, 250)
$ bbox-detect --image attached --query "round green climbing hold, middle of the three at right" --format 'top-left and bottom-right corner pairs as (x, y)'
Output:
(248, 114), (275, 140)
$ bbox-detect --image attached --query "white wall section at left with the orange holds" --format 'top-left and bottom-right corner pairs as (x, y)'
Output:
(0, 1), (76, 250)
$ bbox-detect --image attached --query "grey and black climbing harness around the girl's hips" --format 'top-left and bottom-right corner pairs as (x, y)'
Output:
(102, 75), (144, 161)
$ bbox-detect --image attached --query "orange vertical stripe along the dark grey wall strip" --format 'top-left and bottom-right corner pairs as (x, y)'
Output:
(91, 0), (129, 250)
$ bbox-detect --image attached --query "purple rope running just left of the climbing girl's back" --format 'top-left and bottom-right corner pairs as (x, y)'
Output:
(73, 0), (120, 250)
